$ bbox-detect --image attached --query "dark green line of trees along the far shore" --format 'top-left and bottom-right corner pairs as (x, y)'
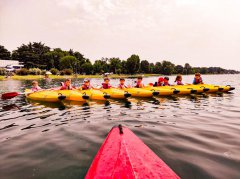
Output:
(0, 42), (240, 75)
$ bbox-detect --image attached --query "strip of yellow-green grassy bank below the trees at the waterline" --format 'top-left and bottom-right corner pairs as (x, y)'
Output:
(0, 74), (159, 80)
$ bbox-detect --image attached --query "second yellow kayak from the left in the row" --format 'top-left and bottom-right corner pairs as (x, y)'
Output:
(55, 90), (89, 101)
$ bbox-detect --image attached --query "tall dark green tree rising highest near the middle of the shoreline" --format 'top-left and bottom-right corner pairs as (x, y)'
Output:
(126, 55), (140, 74)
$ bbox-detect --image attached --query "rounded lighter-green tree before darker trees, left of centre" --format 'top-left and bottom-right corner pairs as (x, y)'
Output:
(60, 55), (79, 72)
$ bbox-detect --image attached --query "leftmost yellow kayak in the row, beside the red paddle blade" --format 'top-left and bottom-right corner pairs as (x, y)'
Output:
(25, 89), (66, 102)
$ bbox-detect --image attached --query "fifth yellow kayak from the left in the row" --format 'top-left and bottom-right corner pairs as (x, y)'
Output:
(122, 88), (159, 98)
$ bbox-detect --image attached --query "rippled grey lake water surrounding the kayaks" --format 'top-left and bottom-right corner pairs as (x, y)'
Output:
(0, 75), (240, 179)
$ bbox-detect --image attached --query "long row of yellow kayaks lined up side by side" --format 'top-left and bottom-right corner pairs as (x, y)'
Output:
(25, 84), (235, 102)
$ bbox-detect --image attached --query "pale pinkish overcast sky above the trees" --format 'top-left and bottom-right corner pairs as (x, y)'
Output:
(0, 0), (240, 70)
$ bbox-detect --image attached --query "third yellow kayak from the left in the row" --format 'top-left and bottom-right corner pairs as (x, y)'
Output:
(80, 89), (110, 100)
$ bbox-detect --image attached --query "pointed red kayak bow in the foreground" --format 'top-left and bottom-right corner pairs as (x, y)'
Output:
(85, 125), (180, 179)
